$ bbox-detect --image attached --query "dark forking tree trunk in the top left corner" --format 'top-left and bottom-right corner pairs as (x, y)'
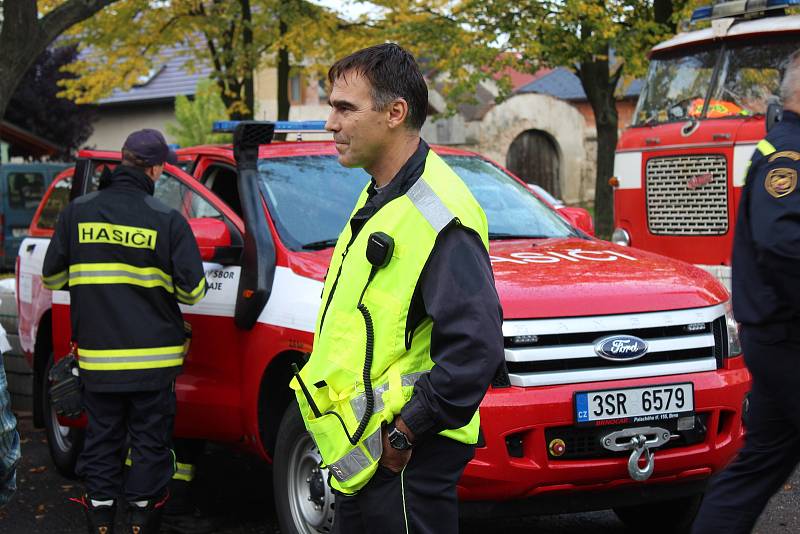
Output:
(0, 0), (115, 118)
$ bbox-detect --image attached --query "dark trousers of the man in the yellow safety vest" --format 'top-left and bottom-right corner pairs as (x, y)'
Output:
(333, 435), (475, 534)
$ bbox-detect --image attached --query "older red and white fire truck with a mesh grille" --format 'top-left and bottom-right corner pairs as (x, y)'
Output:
(612, 0), (800, 287)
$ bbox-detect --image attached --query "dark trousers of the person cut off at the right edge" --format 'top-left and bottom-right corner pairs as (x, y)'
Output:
(692, 325), (800, 534)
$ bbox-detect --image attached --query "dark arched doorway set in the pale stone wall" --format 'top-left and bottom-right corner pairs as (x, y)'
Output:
(506, 130), (561, 198)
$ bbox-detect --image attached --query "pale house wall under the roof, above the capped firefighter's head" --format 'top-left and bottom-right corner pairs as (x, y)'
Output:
(84, 102), (177, 150)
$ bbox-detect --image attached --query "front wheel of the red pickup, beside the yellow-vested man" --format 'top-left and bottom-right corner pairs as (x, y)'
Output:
(272, 401), (334, 534)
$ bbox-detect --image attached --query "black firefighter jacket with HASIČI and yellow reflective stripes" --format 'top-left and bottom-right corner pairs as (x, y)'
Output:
(42, 166), (206, 392)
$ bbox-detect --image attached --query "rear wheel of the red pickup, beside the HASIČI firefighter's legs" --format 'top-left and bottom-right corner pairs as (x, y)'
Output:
(39, 352), (85, 479)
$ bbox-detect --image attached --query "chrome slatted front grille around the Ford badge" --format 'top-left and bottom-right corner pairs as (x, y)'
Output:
(500, 305), (727, 387)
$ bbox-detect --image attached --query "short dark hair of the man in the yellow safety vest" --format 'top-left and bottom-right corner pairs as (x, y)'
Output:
(328, 43), (428, 130)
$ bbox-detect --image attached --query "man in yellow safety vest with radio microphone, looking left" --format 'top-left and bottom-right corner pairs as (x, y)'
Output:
(292, 44), (503, 534)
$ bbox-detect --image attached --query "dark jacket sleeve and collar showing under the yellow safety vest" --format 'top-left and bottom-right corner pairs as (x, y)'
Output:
(350, 139), (505, 439)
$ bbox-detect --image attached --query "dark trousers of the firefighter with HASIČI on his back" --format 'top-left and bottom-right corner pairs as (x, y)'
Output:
(77, 386), (175, 502)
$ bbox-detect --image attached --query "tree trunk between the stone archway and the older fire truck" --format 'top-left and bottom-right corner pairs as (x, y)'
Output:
(578, 54), (620, 239)
